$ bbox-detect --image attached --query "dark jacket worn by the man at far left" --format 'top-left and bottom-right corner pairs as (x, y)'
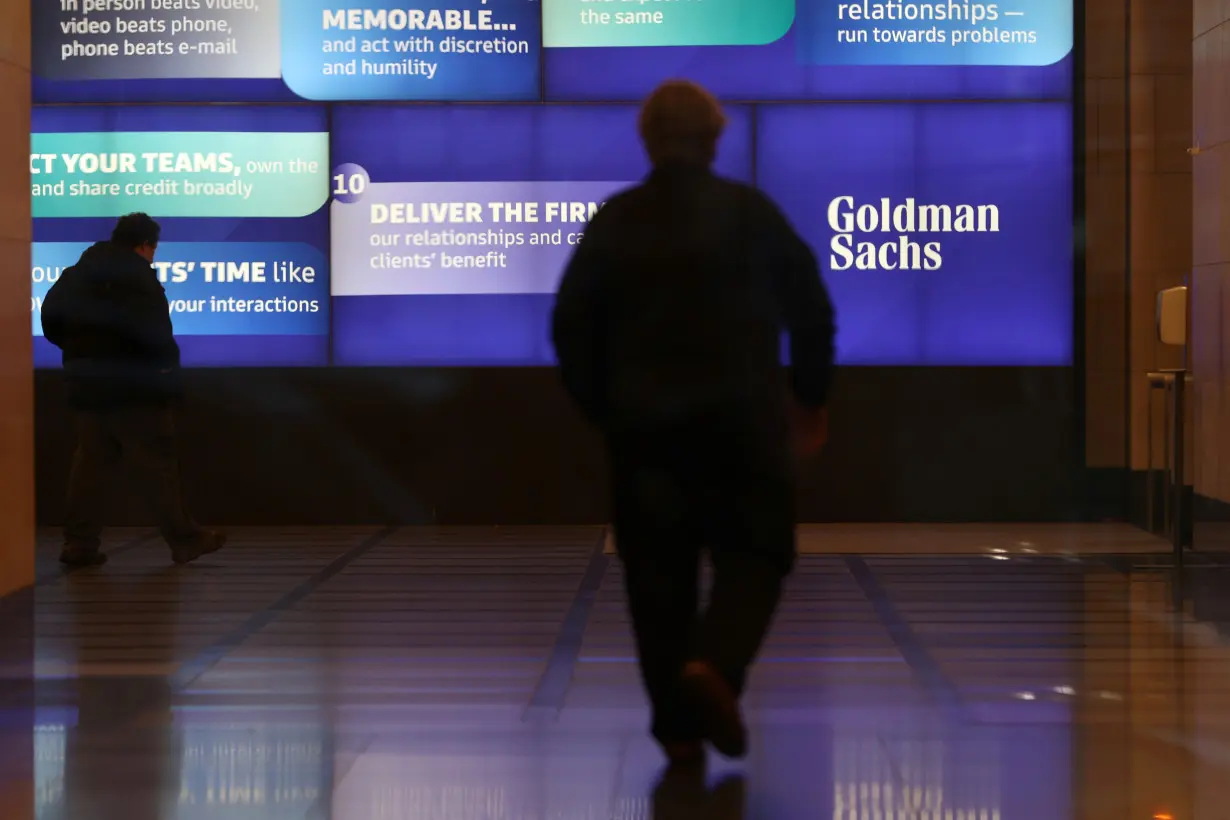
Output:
(43, 242), (180, 409)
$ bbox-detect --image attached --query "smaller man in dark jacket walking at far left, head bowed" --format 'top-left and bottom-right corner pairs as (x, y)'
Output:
(43, 214), (224, 567)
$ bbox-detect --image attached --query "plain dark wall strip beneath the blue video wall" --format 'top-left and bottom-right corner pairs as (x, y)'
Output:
(36, 368), (1085, 525)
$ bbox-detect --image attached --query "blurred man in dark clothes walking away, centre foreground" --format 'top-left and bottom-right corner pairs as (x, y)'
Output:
(554, 82), (834, 763)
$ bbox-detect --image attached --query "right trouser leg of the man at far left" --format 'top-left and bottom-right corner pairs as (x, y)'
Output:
(114, 407), (202, 546)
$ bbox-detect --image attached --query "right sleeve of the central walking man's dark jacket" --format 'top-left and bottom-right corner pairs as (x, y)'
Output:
(764, 193), (836, 409)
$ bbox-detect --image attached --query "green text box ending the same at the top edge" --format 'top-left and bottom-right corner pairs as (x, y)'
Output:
(542, 0), (795, 48)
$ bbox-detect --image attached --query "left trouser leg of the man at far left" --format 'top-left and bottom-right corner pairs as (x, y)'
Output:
(64, 412), (121, 550)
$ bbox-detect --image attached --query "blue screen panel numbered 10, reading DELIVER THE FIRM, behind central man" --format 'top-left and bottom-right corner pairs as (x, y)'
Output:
(332, 106), (752, 366)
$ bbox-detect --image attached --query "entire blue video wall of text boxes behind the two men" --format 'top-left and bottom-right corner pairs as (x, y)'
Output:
(30, 0), (1075, 366)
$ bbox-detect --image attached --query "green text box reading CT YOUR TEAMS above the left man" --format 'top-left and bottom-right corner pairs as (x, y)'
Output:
(30, 132), (328, 219)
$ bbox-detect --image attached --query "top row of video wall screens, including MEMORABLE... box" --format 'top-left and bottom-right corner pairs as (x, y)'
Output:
(32, 0), (1073, 102)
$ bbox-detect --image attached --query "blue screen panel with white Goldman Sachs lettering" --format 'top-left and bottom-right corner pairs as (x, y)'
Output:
(756, 103), (1073, 365)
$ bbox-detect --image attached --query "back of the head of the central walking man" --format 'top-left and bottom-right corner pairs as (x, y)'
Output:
(638, 80), (726, 165)
